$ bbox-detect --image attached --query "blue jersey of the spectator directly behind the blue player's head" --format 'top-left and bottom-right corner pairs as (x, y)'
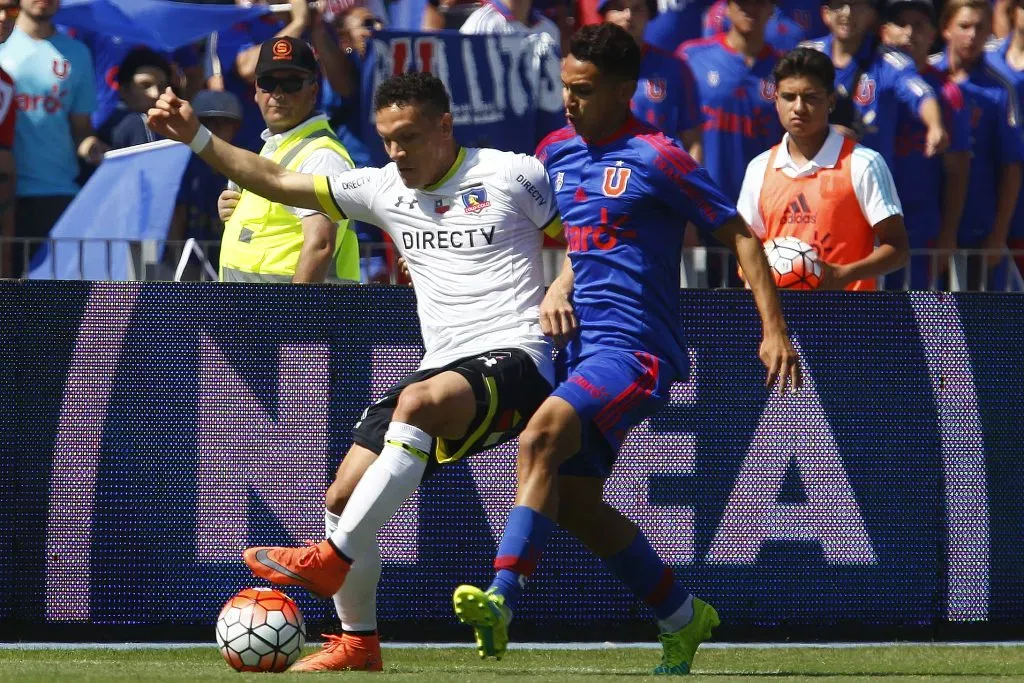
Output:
(632, 45), (701, 137)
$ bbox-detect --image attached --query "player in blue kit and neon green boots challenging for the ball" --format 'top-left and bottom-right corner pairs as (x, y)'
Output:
(454, 24), (800, 674)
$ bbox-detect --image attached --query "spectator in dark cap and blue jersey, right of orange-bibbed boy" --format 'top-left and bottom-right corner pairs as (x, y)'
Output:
(882, 0), (971, 290)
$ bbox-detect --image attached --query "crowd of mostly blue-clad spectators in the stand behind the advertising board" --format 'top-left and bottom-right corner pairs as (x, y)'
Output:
(0, 0), (1024, 288)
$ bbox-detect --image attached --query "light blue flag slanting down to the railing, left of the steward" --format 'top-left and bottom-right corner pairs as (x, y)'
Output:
(29, 140), (191, 280)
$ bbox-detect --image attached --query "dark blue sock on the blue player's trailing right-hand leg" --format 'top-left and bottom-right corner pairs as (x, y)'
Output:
(604, 529), (689, 620)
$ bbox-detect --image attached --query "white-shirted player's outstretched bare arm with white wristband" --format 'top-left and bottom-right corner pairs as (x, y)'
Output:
(146, 88), (322, 211)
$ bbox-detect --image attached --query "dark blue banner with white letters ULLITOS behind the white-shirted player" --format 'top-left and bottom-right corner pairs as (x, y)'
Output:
(362, 31), (565, 165)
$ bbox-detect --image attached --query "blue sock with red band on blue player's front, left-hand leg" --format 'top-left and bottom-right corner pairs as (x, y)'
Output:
(490, 505), (555, 609)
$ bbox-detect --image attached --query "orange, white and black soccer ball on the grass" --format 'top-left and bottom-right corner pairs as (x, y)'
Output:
(210, 588), (306, 672)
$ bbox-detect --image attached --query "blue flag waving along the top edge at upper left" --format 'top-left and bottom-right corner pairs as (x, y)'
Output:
(54, 0), (270, 52)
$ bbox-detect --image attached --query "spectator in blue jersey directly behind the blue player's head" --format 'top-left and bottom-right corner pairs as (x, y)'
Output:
(597, 0), (701, 154)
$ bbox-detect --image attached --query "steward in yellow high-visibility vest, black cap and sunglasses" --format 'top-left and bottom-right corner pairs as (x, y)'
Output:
(217, 37), (359, 284)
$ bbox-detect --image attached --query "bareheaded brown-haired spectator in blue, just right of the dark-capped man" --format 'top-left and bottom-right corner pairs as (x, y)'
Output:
(933, 0), (1024, 289)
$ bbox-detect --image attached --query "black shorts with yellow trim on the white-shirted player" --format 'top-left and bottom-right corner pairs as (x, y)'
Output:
(352, 348), (552, 475)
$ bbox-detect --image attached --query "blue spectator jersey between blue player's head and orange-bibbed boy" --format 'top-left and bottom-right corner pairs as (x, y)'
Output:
(676, 34), (782, 202)
